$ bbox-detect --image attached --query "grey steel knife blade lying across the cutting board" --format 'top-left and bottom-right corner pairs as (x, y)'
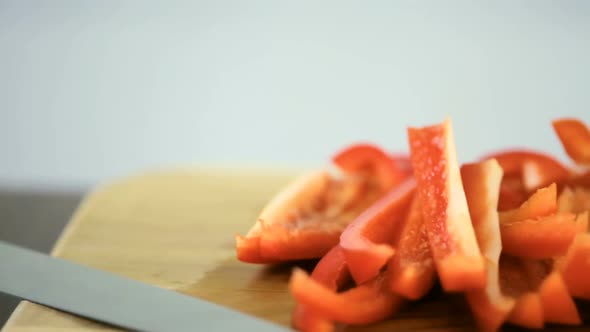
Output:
(0, 241), (288, 332)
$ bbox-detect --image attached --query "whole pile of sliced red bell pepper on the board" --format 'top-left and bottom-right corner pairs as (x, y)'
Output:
(236, 118), (590, 331)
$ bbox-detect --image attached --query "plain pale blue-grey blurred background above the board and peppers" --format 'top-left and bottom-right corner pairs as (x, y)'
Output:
(0, 0), (590, 187)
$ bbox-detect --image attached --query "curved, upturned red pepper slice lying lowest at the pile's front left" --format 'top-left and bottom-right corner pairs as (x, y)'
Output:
(289, 269), (403, 325)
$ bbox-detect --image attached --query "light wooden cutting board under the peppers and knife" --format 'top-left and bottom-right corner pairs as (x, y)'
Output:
(3, 170), (590, 332)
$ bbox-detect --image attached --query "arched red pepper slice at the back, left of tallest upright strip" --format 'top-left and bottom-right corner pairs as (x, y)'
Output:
(332, 143), (412, 190)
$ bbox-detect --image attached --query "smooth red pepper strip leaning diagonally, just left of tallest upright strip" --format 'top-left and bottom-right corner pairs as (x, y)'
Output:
(340, 178), (416, 284)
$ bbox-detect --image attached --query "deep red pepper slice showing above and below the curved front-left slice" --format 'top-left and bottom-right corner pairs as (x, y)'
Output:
(292, 245), (350, 332)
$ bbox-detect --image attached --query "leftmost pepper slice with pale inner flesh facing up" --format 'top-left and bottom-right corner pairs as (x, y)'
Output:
(236, 171), (342, 263)
